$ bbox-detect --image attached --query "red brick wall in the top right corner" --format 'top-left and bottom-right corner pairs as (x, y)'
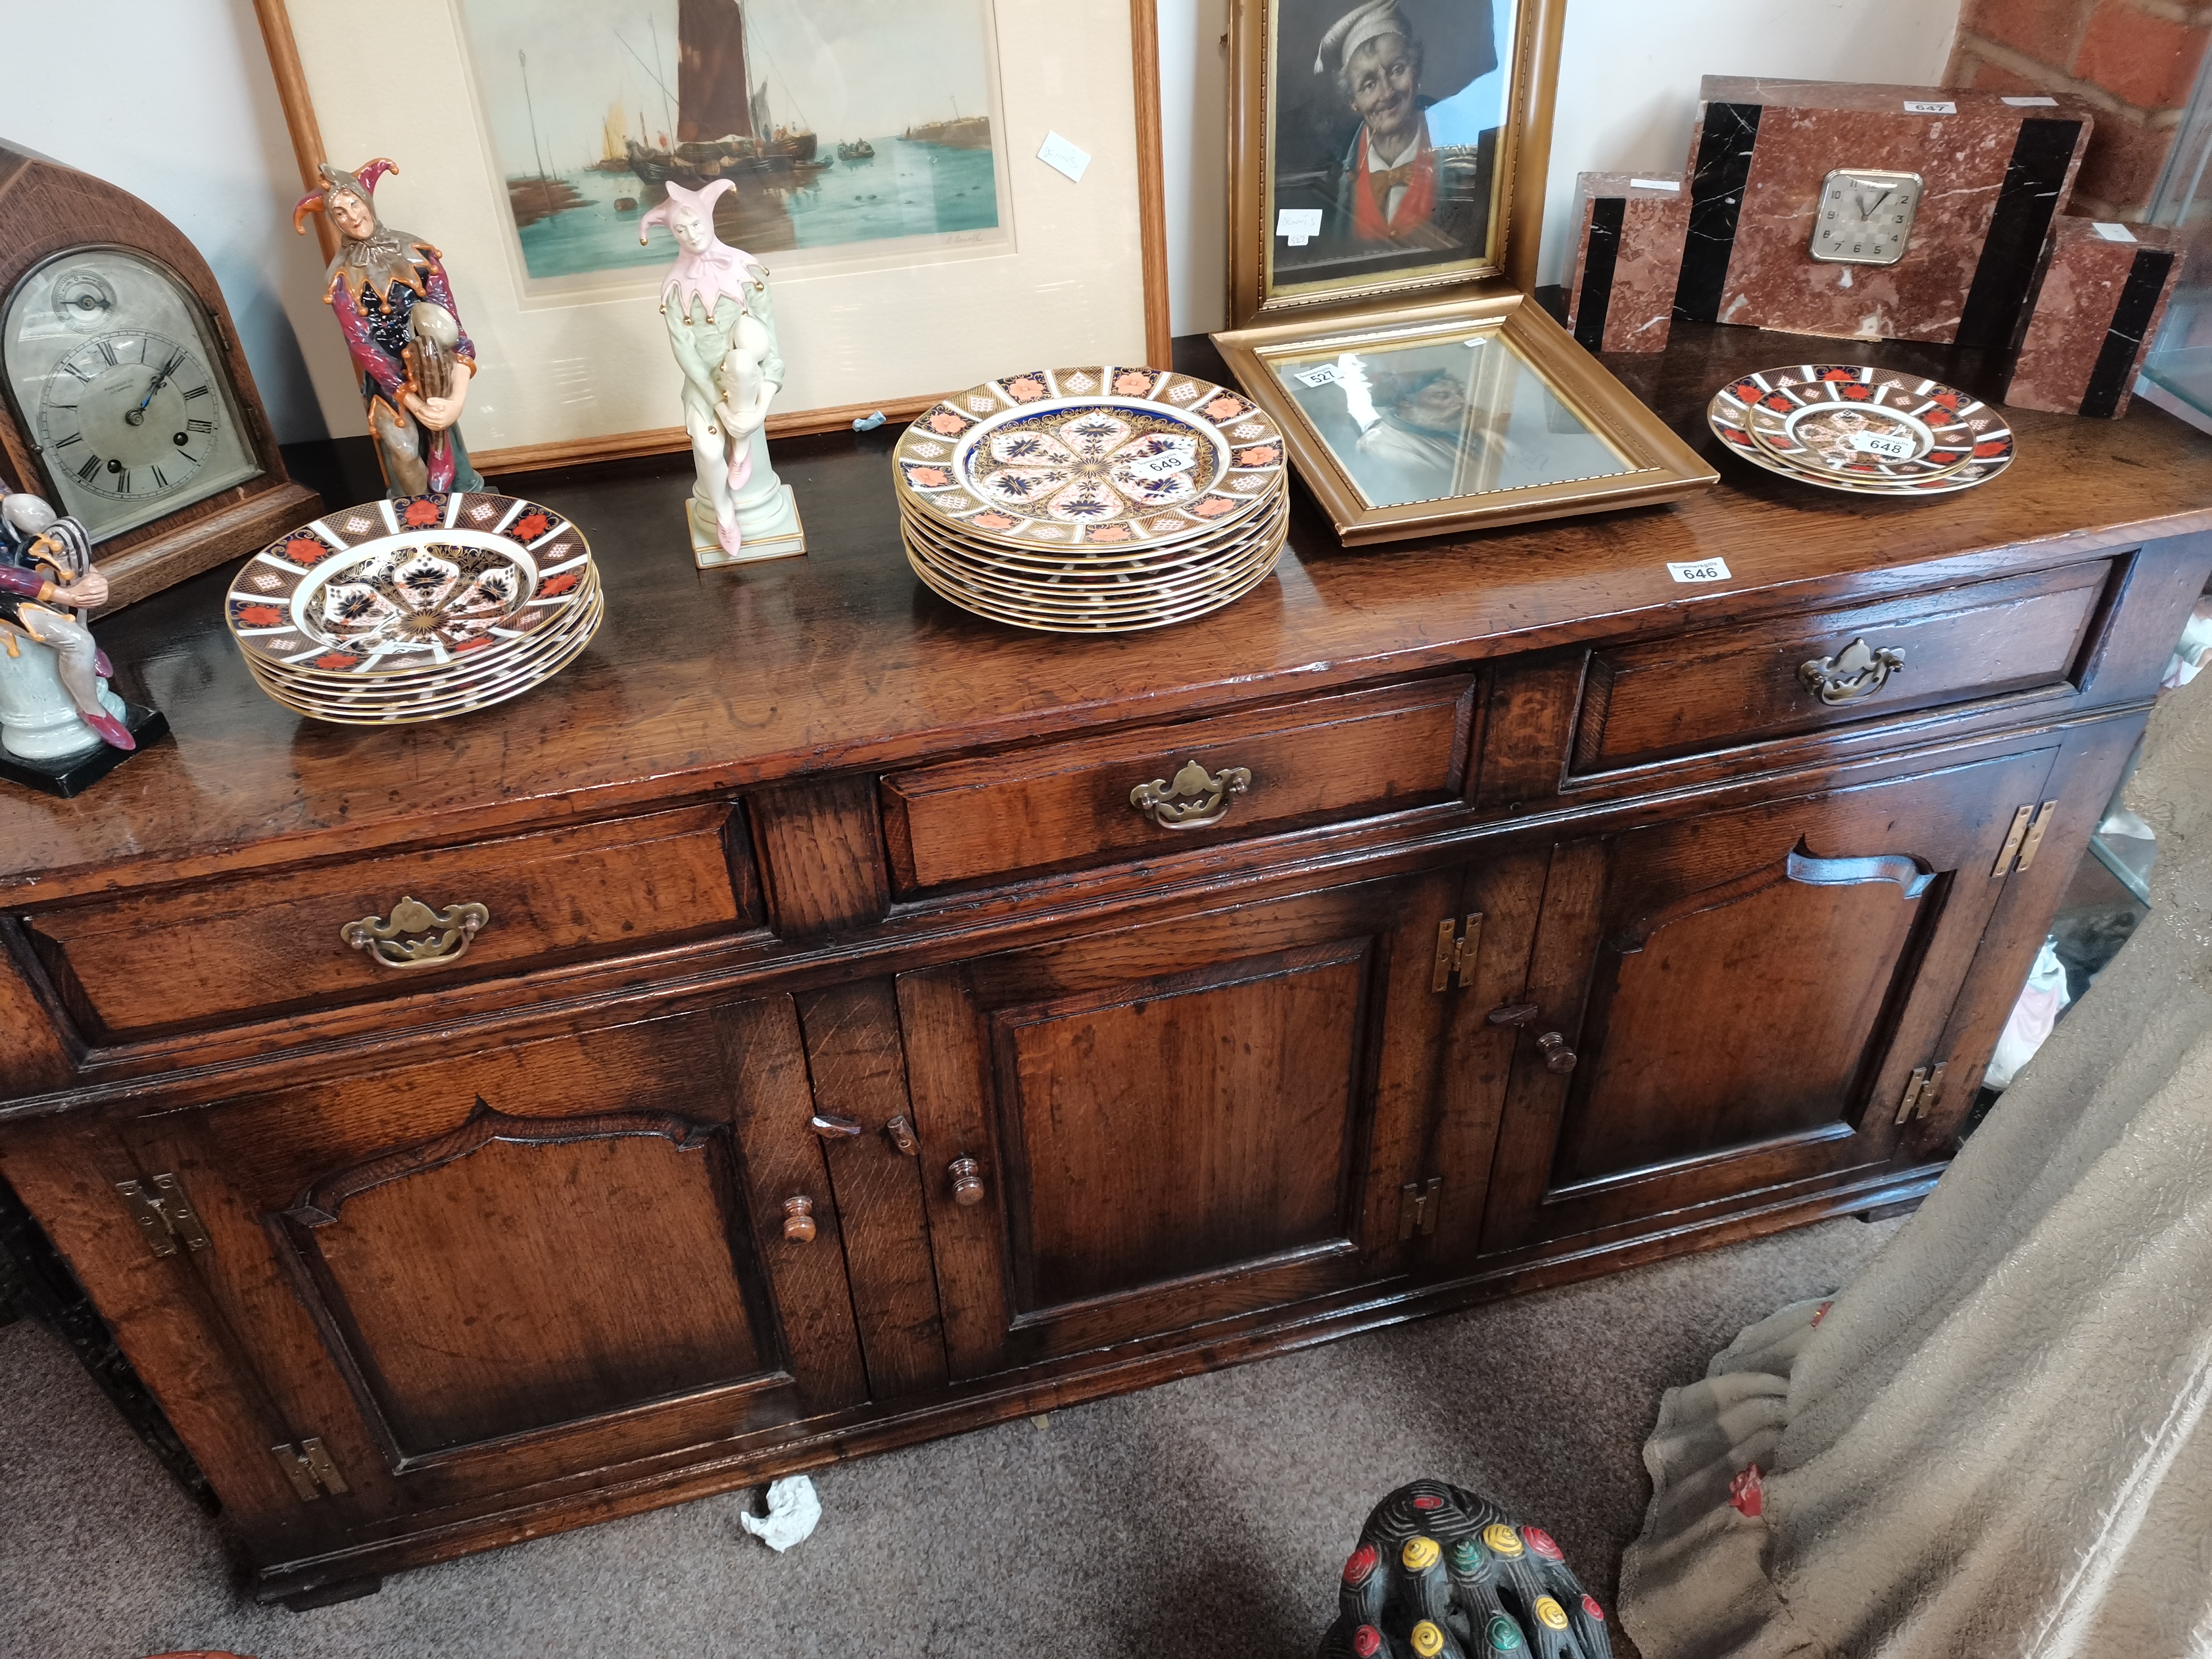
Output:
(1947, 0), (2212, 221)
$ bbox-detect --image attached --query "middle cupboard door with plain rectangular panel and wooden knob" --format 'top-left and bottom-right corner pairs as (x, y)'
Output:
(898, 872), (1460, 1376)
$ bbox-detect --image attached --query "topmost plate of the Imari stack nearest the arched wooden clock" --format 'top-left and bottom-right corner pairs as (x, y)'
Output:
(223, 491), (590, 679)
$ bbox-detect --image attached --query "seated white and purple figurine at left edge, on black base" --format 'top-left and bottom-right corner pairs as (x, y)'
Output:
(0, 484), (137, 761)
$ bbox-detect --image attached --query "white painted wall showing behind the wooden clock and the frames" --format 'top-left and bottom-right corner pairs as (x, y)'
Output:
(0, 0), (1960, 440)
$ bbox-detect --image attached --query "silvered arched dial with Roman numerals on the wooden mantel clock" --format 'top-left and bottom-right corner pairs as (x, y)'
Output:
(0, 248), (261, 542)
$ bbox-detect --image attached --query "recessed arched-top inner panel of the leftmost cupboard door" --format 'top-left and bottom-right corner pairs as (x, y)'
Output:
(281, 1104), (769, 1458)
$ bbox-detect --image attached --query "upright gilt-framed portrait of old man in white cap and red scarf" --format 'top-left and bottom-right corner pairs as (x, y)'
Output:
(1230, 0), (1564, 327)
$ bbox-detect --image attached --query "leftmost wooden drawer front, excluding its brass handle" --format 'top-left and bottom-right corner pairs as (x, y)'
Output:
(20, 803), (759, 1042)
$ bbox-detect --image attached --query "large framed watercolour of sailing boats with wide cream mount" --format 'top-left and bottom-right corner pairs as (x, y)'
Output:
(257, 0), (1168, 471)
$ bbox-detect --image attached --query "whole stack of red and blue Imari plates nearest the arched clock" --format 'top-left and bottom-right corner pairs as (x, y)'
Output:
(223, 491), (606, 725)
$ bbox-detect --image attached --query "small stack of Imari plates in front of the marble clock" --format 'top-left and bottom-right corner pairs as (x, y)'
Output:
(1706, 363), (2013, 495)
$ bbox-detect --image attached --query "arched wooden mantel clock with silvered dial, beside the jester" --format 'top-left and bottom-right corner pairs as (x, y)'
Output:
(0, 146), (321, 606)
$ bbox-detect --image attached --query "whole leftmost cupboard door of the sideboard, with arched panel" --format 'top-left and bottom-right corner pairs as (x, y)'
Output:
(114, 998), (867, 1515)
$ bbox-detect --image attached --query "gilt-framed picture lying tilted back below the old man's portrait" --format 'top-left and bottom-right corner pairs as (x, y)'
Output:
(1214, 294), (1719, 544)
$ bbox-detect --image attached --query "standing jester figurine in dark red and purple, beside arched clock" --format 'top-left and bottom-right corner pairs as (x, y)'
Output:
(292, 157), (484, 500)
